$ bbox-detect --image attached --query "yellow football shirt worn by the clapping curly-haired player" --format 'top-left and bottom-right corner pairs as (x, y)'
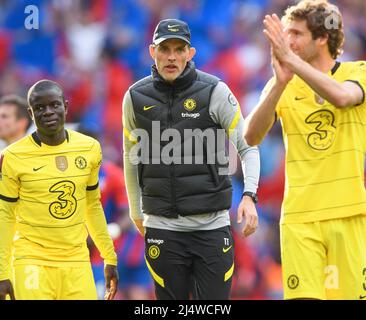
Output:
(264, 61), (366, 223)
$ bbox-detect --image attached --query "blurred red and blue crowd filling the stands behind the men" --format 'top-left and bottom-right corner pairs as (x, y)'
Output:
(0, 0), (366, 299)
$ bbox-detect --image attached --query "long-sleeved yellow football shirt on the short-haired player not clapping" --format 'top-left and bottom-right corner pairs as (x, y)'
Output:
(0, 130), (117, 280)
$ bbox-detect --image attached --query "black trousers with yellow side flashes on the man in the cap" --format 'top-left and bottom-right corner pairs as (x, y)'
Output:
(145, 226), (234, 300)
